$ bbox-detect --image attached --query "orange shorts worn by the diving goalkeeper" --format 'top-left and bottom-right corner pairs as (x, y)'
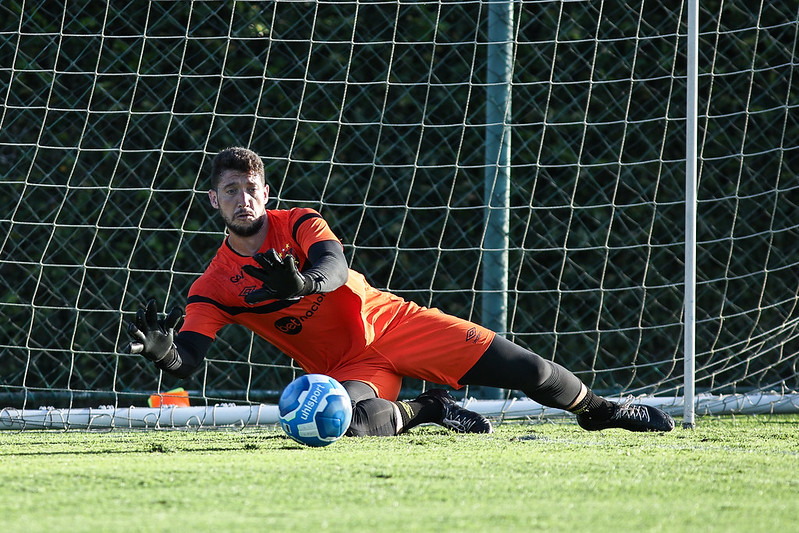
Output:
(328, 302), (496, 400)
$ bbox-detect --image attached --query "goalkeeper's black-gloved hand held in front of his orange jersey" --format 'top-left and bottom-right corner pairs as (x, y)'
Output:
(242, 248), (310, 304)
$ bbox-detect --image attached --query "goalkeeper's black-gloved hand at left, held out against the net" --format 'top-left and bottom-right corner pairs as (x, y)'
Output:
(127, 299), (183, 363)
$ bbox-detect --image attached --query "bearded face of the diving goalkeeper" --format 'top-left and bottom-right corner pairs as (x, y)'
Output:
(208, 170), (269, 237)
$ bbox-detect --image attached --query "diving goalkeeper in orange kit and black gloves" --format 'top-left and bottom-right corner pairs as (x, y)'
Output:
(127, 147), (674, 436)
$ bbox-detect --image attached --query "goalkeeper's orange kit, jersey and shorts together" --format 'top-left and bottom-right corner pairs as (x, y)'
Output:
(181, 208), (494, 399)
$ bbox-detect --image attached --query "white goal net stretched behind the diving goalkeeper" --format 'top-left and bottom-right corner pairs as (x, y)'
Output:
(0, 0), (799, 427)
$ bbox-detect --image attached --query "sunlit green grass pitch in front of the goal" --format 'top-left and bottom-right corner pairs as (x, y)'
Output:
(0, 416), (799, 533)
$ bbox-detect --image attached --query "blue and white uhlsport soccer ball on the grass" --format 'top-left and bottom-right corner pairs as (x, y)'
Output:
(277, 374), (352, 446)
